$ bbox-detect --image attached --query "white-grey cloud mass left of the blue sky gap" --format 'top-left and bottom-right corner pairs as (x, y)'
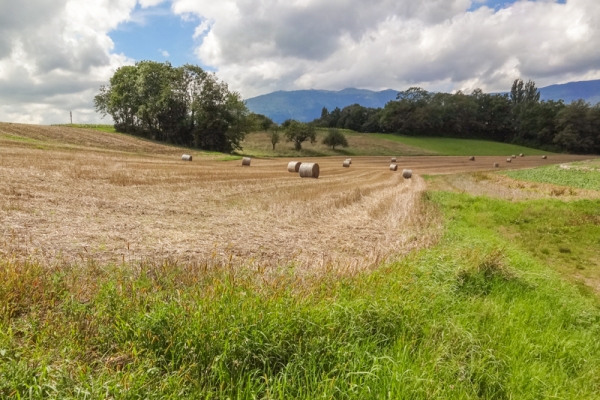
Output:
(0, 0), (136, 123)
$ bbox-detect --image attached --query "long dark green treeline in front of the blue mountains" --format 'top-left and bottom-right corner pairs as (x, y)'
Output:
(313, 79), (600, 153)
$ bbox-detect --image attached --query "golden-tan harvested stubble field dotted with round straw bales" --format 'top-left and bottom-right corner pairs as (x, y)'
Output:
(0, 124), (584, 270)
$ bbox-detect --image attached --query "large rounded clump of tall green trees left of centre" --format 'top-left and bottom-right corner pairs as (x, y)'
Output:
(94, 61), (250, 152)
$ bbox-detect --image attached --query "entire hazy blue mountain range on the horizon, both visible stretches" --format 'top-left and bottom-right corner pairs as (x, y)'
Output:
(246, 80), (600, 123)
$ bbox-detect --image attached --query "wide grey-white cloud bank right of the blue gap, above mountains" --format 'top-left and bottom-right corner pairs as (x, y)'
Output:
(172, 0), (600, 97)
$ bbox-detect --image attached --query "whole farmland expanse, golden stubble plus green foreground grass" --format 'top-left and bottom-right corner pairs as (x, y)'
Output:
(0, 124), (600, 399)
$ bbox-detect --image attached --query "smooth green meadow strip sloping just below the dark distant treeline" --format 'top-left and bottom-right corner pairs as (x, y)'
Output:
(368, 133), (552, 156)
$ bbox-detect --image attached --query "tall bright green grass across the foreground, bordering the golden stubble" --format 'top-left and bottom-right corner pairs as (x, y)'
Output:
(0, 192), (600, 399)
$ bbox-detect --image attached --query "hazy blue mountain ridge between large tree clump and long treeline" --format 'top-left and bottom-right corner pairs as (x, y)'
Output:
(246, 88), (398, 123)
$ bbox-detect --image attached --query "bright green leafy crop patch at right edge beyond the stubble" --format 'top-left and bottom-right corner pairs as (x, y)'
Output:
(504, 160), (600, 190)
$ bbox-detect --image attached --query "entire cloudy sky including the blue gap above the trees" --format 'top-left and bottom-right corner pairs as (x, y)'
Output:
(0, 0), (600, 124)
